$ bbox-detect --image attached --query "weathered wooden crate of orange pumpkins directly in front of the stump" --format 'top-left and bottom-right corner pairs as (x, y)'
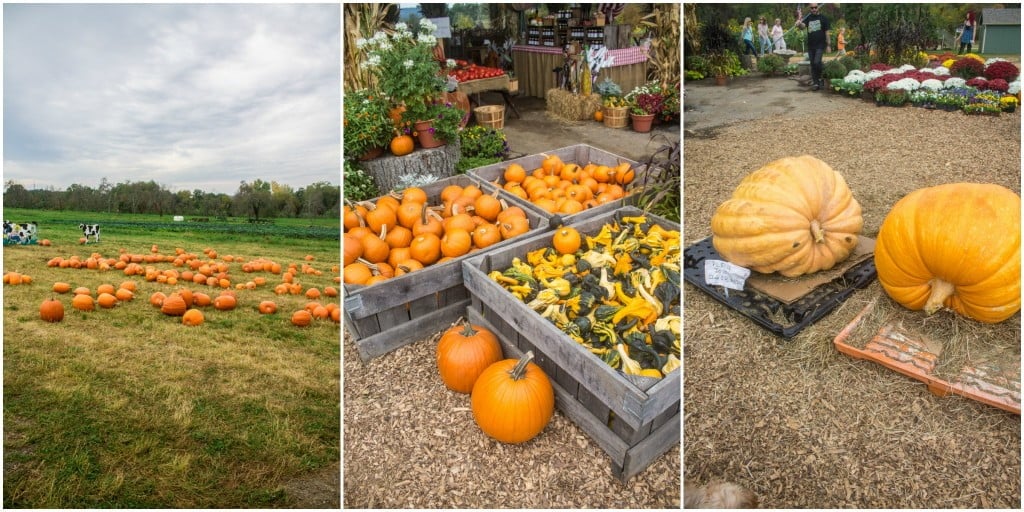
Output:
(342, 175), (548, 361)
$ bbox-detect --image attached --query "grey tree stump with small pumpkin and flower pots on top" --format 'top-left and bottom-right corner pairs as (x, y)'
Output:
(362, 138), (462, 193)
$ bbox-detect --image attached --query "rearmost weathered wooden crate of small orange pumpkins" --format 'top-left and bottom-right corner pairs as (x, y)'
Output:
(469, 144), (647, 224)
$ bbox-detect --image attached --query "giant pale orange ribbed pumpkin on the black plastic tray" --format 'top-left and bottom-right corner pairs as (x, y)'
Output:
(711, 156), (864, 278)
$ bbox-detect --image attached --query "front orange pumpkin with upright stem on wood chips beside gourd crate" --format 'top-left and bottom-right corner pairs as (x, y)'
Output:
(470, 351), (555, 444)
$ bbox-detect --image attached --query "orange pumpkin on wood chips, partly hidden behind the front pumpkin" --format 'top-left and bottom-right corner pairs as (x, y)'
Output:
(437, 322), (502, 394)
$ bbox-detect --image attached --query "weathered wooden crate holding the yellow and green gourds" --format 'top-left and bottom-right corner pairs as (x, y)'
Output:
(462, 203), (682, 481)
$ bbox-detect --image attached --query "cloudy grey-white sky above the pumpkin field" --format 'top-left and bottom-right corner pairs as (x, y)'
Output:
(3, 4), (341, 194)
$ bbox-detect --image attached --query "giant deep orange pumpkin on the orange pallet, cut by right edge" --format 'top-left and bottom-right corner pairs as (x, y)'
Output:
(874, 183), (1021, 324)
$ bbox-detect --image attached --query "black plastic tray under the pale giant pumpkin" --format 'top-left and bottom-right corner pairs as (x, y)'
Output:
(683, 237), (878, 339)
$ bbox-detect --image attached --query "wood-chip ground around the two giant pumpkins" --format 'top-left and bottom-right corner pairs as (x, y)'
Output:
(683, 94), (1021, 508)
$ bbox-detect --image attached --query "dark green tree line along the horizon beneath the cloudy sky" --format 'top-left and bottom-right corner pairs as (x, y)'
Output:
(3, 177), (341, 219)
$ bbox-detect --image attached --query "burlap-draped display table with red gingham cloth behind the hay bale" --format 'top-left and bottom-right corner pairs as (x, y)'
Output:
(512, 45), (647, 98)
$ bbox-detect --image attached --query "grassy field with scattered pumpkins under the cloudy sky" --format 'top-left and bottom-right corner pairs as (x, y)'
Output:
(3, 206), (340, 508)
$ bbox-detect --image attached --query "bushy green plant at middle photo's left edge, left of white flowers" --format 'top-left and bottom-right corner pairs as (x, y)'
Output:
(342, 89), (394, 161)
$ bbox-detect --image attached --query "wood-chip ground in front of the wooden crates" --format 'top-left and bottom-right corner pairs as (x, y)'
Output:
(343, 333), (681, 509)
